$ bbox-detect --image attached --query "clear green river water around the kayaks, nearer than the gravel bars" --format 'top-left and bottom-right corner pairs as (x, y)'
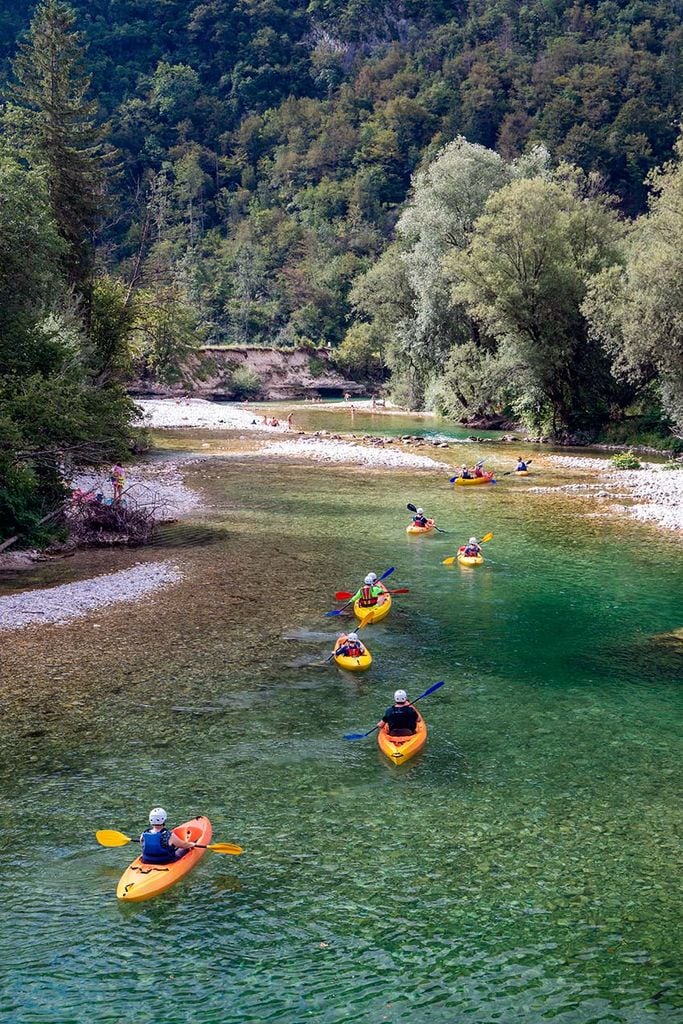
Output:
(0, 436), (683, 1024)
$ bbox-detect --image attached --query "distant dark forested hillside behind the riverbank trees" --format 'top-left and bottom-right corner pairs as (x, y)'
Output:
(0, 0), (683, 356)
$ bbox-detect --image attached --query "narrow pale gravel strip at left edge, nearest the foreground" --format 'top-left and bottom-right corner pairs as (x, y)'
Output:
(0, 561), (182, 631)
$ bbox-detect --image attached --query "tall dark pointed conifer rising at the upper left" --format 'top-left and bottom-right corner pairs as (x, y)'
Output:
(12, 0), (105, 293)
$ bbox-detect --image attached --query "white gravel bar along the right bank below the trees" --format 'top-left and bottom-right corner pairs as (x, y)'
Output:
(548, 456), (683, 530)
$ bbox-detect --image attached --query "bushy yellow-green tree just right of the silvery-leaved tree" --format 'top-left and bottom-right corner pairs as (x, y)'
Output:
(454, 167), (623, 435)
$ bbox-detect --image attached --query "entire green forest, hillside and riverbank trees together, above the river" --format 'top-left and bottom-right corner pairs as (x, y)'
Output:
(0, 0), (683, 532)
